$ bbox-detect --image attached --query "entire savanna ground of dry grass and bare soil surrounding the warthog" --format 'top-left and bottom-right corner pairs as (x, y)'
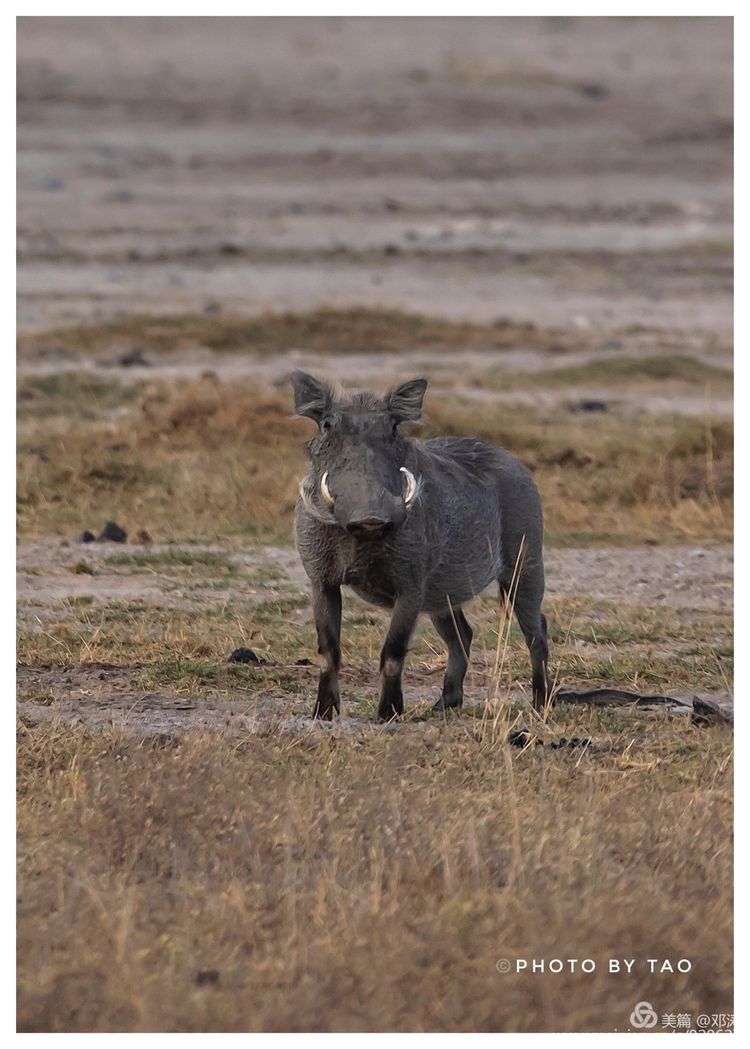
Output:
(18, 19), (732, 1031)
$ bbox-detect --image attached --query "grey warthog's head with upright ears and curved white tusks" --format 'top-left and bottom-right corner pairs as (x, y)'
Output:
(292, 371), (427, 539)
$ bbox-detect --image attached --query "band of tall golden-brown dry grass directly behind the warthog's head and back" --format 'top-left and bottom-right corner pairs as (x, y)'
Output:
(18, 376), (732, 543)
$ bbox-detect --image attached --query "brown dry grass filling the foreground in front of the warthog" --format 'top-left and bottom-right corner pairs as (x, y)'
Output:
(19, 711), (732, 1031)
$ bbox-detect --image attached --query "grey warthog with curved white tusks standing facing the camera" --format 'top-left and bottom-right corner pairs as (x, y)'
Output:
(292, 371), (550, 720)
